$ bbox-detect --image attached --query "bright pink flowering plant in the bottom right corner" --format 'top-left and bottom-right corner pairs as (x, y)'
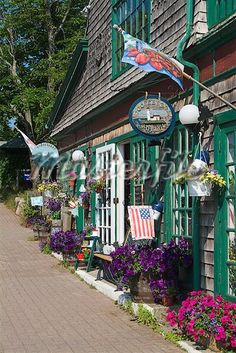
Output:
(166, 291), (236, 352)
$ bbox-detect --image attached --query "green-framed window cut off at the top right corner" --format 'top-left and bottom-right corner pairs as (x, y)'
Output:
(207, 0), (236, 28)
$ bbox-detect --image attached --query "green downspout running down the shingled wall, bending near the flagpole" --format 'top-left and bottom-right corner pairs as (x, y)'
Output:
(176, 0), (201, 290)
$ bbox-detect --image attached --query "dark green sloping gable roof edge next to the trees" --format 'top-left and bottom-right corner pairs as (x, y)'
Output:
(46, 39), (88, 129)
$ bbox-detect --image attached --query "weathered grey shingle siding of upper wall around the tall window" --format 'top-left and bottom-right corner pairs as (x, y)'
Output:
(54, 0), (206, 133)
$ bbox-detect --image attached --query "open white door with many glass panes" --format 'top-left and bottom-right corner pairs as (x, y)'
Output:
(96, 144), (117, 245)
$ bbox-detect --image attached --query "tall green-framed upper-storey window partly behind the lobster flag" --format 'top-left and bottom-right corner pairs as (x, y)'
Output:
(112, 0), (150, 77)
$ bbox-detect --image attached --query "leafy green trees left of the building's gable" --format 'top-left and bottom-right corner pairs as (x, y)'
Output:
(0, 0), (88, 143)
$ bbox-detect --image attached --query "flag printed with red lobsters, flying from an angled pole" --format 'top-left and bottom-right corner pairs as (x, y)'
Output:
(121, 31), (184, 89)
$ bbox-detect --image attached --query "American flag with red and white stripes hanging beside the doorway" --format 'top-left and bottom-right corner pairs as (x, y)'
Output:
(128, 206), (155, 240)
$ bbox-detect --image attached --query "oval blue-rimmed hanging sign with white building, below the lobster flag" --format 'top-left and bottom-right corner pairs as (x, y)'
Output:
(129, 95), (175, 140)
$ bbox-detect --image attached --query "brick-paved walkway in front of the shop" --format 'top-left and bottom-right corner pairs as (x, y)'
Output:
(0, 204), (182, 353)
